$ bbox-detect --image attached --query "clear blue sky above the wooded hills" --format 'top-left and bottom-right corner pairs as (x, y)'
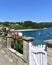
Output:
(0, 0), (52, 22)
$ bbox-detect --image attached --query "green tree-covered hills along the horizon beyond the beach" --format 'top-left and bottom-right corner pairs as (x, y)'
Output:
(0, 21), (52, 29)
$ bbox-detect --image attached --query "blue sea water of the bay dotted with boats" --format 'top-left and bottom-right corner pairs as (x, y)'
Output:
(22, 28), (52, 45)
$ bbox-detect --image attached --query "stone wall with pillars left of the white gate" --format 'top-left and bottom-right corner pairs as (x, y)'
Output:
(1, 37), (33, 65)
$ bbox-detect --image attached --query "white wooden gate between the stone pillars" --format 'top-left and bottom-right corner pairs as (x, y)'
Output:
(29, 42), (47, 65)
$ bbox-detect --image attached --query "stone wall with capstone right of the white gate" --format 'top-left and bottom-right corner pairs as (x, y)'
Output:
(45, 39), (52, 65)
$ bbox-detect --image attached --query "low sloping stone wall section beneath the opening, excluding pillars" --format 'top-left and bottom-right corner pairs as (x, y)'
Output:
(4, 48), (28, 65)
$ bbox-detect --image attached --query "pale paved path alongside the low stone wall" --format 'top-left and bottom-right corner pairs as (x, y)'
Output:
(0, 45), (17, 65)
